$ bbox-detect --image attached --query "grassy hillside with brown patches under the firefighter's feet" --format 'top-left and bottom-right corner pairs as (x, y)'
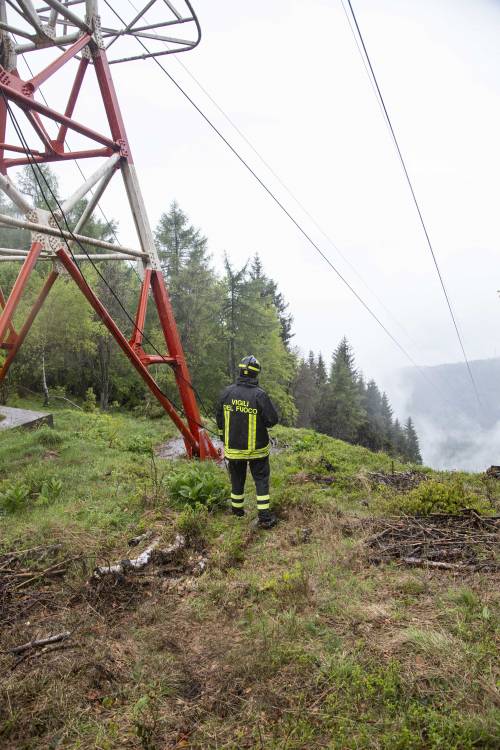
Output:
(0, 404), (500, 750)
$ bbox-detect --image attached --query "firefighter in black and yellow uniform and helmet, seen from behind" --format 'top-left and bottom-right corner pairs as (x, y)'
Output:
(217, 355), (278, 529)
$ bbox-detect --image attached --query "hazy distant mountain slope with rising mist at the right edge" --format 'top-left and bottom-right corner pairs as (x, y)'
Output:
(402, 358), (500, 471)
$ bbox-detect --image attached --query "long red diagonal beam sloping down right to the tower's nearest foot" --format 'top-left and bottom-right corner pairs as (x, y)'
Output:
(57, 248), (200, 455)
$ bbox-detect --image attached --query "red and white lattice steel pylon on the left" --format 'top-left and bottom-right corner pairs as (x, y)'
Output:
(0, 0), (217, 458)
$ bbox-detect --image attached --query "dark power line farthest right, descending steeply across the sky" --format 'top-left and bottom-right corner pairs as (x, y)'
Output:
(347, 0), (482, 406)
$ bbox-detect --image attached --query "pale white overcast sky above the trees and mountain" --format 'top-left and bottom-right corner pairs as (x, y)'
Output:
(8, 0), (500, 400)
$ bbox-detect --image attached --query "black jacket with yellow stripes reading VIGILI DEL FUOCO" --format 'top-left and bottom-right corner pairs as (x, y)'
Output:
(216, 377), (278, 459)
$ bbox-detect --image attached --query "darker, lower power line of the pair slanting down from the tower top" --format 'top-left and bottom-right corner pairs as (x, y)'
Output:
(104, 0), (460, 412)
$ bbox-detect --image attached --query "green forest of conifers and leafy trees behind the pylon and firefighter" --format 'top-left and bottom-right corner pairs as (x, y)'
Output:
(0, 165), (421, 461)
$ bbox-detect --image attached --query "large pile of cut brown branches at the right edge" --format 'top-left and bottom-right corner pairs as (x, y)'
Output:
(366, 510), (500, 570)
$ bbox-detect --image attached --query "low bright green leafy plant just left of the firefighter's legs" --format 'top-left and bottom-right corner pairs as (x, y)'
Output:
(165, 461), (229, 510)
